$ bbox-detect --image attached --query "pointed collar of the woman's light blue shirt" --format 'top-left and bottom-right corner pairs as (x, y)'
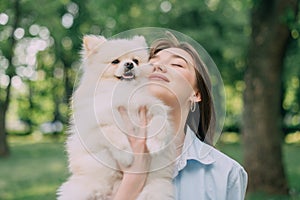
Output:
(176, 127), (215, 175)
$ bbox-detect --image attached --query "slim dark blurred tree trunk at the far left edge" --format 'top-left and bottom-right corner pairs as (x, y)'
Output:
(0, 0), (21, 157)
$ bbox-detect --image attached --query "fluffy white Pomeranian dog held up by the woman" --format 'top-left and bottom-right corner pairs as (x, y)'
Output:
(58, 35), (175, 200)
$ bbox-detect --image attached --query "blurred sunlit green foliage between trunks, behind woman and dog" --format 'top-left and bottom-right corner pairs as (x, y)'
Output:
(0, 0), (300, 134)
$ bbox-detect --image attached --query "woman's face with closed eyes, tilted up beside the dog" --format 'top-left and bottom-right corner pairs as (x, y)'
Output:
(149, 48), (200, 106)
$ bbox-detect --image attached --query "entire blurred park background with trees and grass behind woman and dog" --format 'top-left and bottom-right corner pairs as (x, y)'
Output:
(0, 0), (300, 200)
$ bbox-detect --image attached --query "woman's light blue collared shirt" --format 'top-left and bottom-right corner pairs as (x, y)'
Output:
(173, 128), (248, 200)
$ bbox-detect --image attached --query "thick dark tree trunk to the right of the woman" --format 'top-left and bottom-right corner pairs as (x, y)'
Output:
(243, 0), (298, 194)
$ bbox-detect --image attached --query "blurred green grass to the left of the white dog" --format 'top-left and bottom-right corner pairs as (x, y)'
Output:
(0, 137), (68, 200)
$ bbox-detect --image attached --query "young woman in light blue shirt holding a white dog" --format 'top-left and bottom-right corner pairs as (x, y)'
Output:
(114, 32), (247, 200)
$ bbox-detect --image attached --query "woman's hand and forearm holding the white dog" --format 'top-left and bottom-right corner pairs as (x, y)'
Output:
(114, 107), (151, 200)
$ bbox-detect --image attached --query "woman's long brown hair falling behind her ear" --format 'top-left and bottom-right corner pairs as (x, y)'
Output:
(150, 32), (216, 145)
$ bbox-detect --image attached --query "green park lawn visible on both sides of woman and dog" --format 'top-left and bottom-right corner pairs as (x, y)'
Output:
(0, 137), (300, 200)
